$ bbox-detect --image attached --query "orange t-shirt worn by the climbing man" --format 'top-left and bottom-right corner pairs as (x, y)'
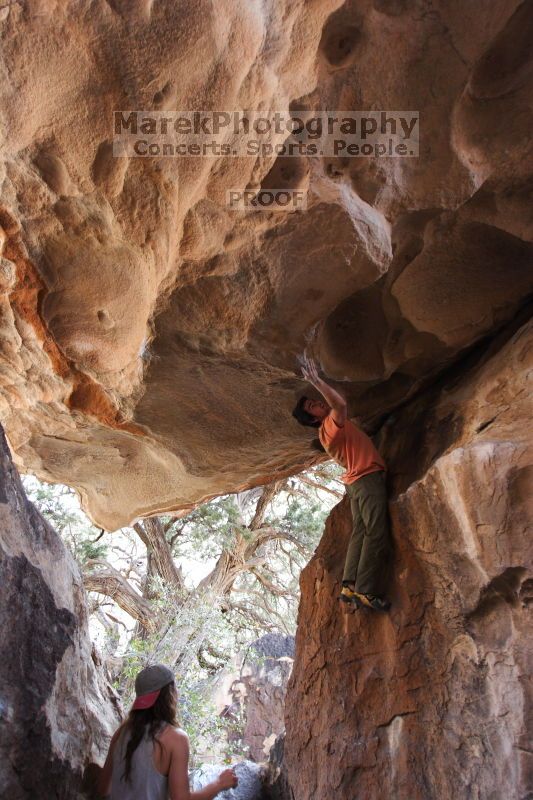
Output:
(318, 412), (386, 483)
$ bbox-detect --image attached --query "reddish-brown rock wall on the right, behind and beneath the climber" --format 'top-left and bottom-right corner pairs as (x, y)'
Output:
(285, 323), (533, 800)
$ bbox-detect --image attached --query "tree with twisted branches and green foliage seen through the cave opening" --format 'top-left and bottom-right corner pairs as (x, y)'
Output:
(25, 464), (342, 756)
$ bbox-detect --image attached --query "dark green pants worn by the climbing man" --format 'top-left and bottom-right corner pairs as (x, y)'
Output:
(342, 470), (391, 595)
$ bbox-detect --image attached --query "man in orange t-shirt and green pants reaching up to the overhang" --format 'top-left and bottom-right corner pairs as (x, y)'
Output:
(292, 357), (391, 611)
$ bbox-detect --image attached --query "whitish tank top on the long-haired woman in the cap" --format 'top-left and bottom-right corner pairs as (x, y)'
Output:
(111, 728), (168, 800)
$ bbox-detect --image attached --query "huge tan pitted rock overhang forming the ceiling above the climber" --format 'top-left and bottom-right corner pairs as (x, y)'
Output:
(0, 0), (533, 529)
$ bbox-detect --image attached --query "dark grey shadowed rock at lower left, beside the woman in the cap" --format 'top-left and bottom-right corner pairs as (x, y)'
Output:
(0, 429), (119, 800)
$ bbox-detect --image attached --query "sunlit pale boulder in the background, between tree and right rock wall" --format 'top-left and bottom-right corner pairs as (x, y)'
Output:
(214, 633), (294, 762)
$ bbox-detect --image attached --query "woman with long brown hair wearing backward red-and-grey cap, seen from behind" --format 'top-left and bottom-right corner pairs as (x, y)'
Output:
(97, 664), (238, 800)
